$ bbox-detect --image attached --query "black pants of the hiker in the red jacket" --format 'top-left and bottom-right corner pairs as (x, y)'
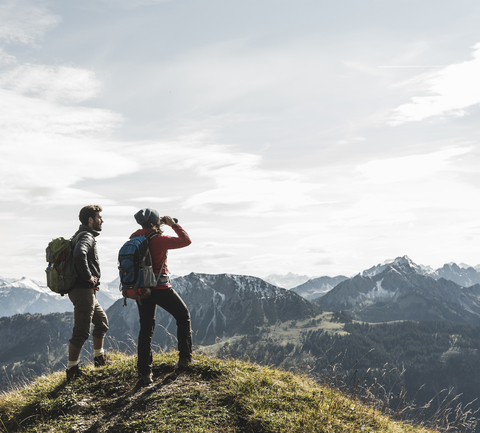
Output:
(137, 289), (192, 375)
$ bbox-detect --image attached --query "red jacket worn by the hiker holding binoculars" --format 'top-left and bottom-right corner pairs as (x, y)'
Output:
(131, 224), (192, 289)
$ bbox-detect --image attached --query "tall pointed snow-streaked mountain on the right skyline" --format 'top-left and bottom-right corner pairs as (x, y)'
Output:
(315, 257), (480, 324)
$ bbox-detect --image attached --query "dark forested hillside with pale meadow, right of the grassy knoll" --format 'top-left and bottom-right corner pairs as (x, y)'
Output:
(202, 312), (480, 426)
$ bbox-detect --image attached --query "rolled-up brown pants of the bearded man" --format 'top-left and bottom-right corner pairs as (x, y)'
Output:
(68, 288), (108, 348)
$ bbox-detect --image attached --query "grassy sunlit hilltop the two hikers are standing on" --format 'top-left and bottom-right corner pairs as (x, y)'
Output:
(0, 353), (440, 433)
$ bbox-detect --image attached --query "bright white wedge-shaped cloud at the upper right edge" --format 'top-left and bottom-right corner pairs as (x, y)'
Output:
(388, 43), (480, 126)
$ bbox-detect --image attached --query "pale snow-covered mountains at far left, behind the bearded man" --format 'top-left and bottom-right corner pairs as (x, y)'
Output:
(0, 277), (121, 317)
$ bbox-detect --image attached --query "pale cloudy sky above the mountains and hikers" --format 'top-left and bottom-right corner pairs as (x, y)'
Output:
(0, 0), (480, 282)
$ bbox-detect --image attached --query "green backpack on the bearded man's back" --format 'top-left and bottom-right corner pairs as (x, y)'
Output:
(45, 232), (82, 296)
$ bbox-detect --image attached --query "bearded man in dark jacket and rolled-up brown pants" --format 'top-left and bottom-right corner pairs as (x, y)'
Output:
(66, 205), (111, 382)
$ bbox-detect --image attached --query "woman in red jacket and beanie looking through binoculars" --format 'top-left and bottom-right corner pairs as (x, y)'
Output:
(131, 208), (192, 385)
